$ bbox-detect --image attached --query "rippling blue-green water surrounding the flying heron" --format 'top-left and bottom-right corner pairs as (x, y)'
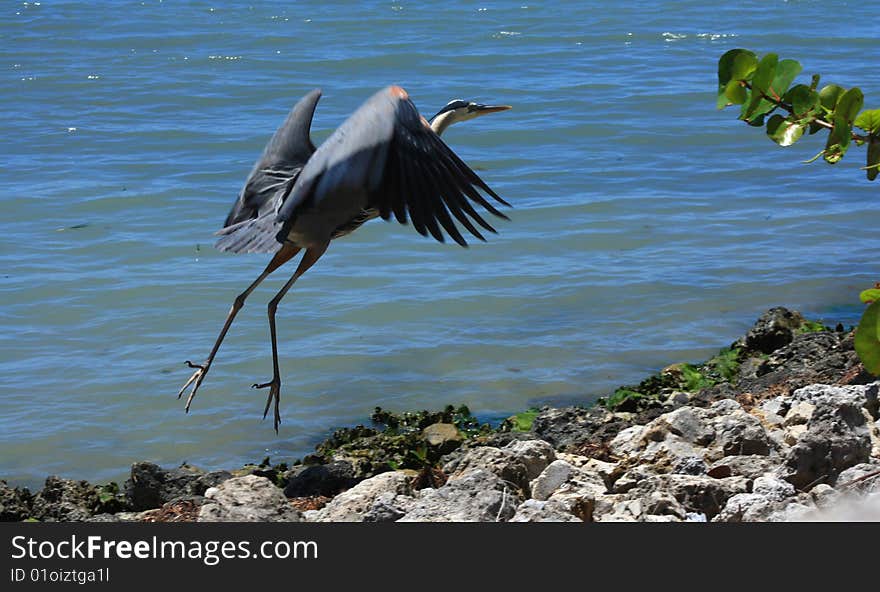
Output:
(0, 0), (880, 487)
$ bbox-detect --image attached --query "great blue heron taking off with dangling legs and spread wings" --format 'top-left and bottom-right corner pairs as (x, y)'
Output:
(177, 86), (510, 433)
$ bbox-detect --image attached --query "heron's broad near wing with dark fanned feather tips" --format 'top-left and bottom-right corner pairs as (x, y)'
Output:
(278, 86), (509, 246)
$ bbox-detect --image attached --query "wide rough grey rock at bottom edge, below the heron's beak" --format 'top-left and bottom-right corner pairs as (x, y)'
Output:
(399, 468), (521, 522)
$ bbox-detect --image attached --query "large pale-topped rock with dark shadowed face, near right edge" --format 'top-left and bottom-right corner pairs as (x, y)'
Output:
(785, 387), (871, 489)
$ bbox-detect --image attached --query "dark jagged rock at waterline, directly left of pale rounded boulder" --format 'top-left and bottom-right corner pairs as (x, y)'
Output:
(123, 462), (232, 510)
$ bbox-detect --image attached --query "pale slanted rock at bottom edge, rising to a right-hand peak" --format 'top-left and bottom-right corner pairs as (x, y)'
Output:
(310, 471), (412, 522)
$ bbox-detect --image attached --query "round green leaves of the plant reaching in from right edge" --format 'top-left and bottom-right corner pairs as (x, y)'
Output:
(716, 49), (880, 375)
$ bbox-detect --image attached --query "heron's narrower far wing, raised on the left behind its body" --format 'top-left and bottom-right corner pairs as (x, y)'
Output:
(217, 89), (321, 252)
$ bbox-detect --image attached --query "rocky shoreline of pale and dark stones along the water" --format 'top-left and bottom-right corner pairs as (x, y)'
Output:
(0, 308), (880, 522)
